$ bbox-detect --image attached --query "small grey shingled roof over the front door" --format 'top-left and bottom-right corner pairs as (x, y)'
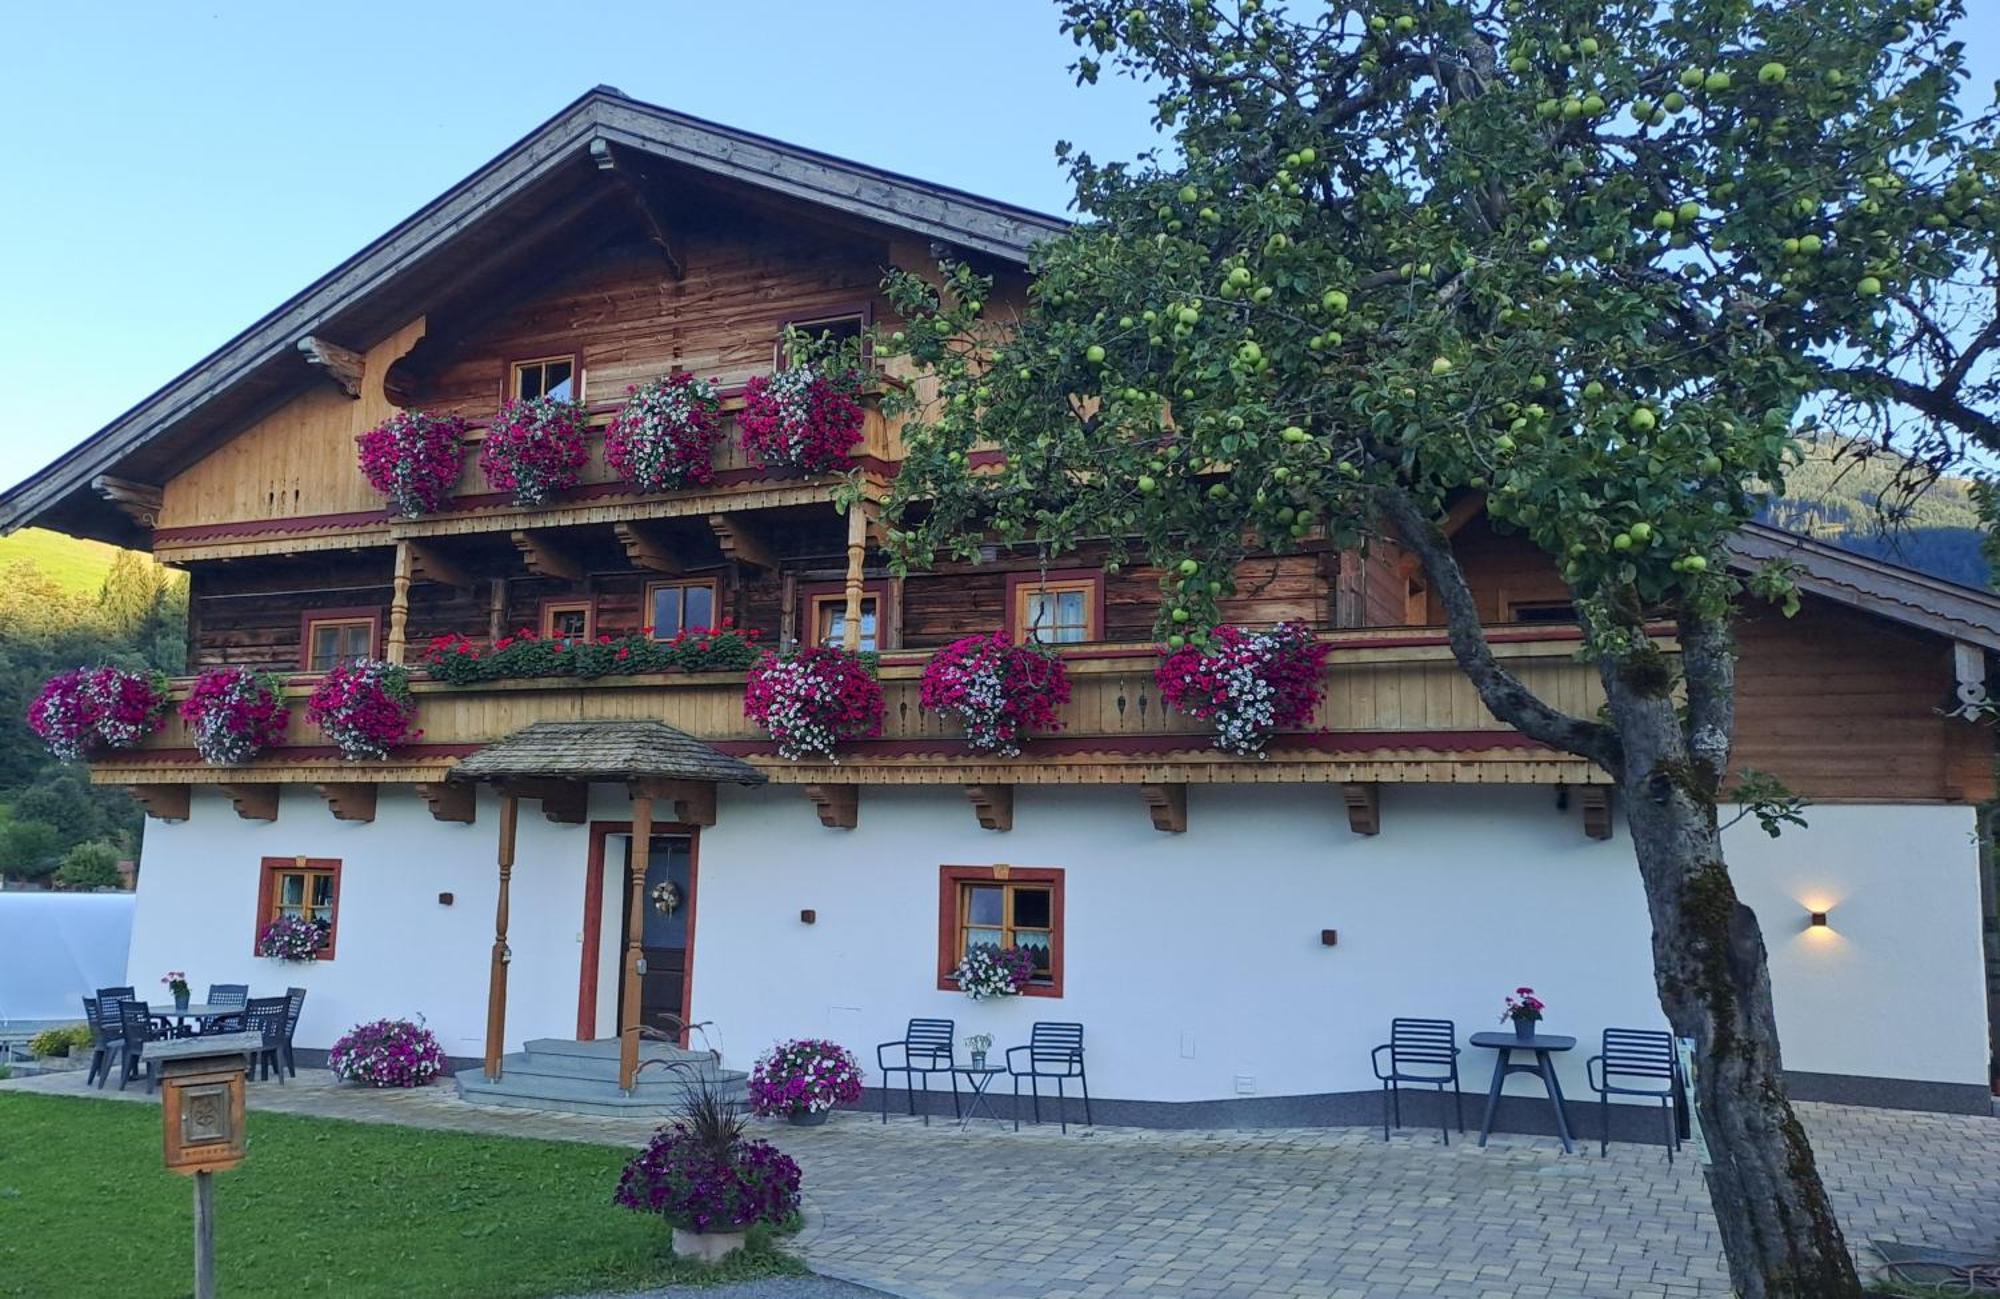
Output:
(452, 721), (764, 785)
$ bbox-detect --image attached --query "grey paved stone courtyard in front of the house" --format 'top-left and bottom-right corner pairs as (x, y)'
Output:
(0, 1071), (2000, 1299)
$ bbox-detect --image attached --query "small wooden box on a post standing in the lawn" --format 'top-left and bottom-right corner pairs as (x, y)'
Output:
(146, 1033), (264, 1299)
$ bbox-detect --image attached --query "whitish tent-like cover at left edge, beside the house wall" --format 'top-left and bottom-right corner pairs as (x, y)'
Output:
(0, 893), (138, 1029)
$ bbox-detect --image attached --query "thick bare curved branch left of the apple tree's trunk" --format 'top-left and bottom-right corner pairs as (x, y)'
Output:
(1376, 488), (1624, 775)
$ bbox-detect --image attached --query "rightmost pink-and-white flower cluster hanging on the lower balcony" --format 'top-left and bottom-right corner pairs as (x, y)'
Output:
(1154, 622), (1332, 757)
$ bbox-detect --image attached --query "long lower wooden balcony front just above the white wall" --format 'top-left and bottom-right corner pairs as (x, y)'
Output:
(92, 628), (1604, 785)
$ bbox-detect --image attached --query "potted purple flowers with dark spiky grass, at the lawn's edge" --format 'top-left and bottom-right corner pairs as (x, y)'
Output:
(612, 1083), (798, 1263)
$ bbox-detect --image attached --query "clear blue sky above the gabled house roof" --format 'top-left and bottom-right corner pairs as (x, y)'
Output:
(0, 0), (2000, 493)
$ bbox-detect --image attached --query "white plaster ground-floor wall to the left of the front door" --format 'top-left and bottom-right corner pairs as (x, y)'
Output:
(128, 785), (604, 1055)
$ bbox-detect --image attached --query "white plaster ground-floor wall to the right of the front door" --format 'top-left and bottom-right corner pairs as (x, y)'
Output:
(694, 785), (1986, 1101)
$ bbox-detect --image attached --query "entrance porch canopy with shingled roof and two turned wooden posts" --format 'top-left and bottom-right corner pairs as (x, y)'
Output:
(450, 721), (766, 1093)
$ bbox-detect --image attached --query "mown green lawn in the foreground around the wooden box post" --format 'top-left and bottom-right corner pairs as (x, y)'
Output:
(0, 1093), (806, 1299)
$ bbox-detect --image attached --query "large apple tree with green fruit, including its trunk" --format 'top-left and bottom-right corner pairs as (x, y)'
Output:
(884, 0), (2000, 1299)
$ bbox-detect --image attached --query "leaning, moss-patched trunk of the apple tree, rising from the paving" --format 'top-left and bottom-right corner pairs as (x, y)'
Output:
(1604, 655), (1862, 1299)
